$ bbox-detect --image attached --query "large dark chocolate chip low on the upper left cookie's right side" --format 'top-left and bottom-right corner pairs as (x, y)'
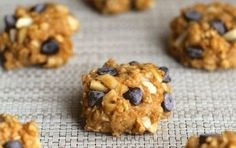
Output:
(41, 39), (59, 55)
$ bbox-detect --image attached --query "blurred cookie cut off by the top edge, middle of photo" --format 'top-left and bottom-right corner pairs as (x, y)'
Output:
(92, 0), (154, 14)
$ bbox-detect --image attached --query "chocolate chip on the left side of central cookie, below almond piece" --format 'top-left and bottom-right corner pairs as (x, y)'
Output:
(88, 90), (105, 107)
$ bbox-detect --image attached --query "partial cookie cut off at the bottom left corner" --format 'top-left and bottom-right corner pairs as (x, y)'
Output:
(0, 114), (41, 148)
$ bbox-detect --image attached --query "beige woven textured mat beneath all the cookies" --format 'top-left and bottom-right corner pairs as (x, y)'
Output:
(0, 0), (236, 148)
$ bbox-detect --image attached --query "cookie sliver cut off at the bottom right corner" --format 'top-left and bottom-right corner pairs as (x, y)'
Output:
(185, 131), (236, 148)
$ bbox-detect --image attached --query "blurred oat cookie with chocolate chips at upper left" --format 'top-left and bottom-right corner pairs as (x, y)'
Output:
(0, 4), (79, 70)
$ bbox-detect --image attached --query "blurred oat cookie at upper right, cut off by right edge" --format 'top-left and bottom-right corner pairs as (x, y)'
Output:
(169, 2), (236, 71)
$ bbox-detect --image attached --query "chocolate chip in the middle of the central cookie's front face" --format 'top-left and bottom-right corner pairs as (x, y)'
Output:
(123, 87), (142, 105)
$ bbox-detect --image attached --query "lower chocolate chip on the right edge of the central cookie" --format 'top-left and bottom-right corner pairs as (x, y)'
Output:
(161, 92), (174, 112)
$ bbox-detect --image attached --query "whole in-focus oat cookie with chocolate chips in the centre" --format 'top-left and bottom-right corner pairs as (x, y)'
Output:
(82, 59), (174, 136)
